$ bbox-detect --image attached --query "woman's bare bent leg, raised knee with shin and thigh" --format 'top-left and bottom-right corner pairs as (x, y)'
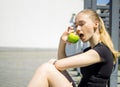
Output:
(28, 63), (73, 87)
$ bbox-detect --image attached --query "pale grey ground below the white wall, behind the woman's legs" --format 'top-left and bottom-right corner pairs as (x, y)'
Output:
(0, 49), (120, 87)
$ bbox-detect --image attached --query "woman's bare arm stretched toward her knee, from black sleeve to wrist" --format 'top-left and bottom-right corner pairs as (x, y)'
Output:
(55, 49), (102, 71)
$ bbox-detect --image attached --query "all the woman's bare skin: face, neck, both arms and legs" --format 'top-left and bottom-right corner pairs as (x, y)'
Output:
(28, 13), (102, 87)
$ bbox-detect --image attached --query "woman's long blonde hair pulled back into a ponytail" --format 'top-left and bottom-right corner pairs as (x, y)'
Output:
(80, 9), (120, 62)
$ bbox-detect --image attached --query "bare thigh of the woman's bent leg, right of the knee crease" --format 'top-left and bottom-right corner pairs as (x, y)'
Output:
(48, 64), (73, 87)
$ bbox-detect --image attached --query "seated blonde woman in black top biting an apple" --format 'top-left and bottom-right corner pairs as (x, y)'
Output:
(28, 9), (120, 87)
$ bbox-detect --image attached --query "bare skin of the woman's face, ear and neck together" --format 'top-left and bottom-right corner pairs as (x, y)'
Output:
(75, 13), (100, 47)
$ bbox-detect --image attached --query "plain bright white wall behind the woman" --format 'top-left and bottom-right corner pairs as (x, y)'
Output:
(0, 0), (83, 48)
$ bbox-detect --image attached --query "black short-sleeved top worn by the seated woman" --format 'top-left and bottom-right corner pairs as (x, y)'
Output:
(78, 43), (114, 87)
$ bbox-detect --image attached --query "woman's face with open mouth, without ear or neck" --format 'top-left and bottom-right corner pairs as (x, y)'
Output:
(75, 13), (95, 42)
